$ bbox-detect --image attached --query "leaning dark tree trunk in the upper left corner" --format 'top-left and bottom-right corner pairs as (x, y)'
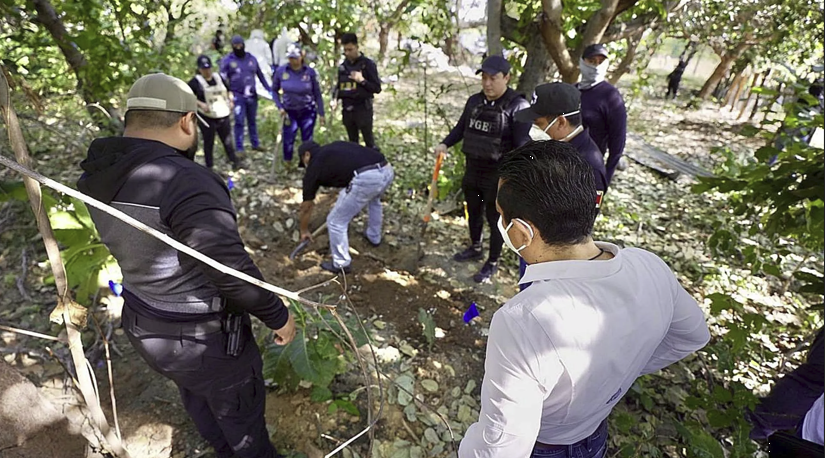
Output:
(31, 0), (123, 134)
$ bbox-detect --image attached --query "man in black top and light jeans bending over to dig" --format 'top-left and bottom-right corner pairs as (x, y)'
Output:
(298, 140), (395, 273)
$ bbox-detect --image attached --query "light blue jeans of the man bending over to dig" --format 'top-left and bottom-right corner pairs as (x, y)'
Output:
(327, 164), (395, 268)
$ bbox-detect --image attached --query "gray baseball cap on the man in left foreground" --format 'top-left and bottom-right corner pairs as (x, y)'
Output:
(126, 73), (198, 113)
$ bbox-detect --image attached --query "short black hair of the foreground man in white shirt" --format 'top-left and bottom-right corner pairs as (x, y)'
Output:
(497, 140), (597, 246)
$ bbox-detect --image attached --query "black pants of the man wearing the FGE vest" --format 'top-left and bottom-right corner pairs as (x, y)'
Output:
(461, 160), (504, 262)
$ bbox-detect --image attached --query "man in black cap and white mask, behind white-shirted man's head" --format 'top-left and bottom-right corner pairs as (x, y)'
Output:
(515, 83), (607, 291)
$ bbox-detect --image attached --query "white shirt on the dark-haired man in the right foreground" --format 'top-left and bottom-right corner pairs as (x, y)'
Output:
(459, 242), (710, 458)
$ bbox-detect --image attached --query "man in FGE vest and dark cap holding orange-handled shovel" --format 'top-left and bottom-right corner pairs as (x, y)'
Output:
(435, 56), (531, 283)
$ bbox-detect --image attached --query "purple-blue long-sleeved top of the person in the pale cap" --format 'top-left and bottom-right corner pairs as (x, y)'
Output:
(272, 64), (324, 116)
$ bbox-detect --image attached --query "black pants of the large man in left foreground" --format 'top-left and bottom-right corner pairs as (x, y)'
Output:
(123, 304), (276, 458)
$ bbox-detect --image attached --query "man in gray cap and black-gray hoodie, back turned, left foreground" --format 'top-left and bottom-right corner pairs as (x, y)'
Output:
(77, 73), (295, 458)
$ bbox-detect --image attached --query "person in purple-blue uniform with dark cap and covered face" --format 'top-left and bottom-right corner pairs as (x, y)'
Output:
(220, 35), (272, 153)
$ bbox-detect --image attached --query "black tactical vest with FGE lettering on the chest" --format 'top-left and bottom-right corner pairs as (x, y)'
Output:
(461, 89), (521, 161)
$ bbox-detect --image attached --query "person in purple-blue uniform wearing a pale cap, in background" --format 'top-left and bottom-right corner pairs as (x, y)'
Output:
(272, 43), (324, 162)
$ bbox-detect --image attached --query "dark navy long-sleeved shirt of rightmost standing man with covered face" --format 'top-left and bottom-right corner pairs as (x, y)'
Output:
(581, 81), (627, 184)
